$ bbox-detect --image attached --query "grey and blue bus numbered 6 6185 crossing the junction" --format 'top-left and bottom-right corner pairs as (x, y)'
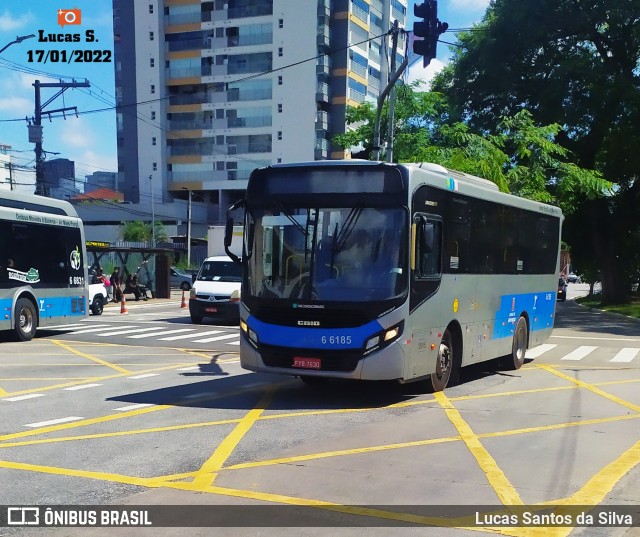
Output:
(225, 161), (563, 390)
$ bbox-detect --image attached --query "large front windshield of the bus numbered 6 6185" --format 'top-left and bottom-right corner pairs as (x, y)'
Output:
(246, 206), (408, 302)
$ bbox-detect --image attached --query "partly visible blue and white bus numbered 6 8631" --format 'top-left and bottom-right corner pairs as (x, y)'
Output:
(0, 191), (88, 341)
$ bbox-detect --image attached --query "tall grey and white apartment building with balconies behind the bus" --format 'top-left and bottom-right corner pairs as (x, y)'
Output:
(113, 0), (407, 221)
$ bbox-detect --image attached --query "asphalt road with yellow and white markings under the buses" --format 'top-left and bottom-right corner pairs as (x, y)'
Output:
(0, 285), (640, 537)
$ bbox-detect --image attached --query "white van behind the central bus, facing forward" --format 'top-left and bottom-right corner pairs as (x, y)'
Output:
(189, 255), (242, 324)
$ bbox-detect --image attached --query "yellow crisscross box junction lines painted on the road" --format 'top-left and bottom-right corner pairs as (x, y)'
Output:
(0, 356), (640, 537)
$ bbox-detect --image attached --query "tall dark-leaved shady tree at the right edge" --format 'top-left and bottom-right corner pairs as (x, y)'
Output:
(433, 0), (640, 302)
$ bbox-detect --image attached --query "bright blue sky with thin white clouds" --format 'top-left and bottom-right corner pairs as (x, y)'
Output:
(0, 0), (489, 191)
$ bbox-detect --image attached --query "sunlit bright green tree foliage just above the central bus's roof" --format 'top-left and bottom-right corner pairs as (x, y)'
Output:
(335, 84), (611, 212)
